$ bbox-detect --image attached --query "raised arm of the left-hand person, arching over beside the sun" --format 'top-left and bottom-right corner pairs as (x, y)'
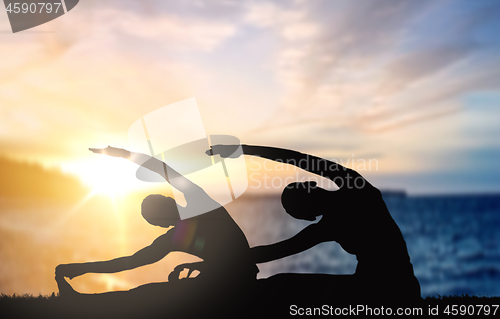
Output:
(89, 146), (208, 196)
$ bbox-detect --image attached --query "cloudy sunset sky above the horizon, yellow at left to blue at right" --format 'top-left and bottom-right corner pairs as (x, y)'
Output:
(0, 0), (500, 193)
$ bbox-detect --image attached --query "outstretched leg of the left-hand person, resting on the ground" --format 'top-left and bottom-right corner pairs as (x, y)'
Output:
(56, 277), (253, 318)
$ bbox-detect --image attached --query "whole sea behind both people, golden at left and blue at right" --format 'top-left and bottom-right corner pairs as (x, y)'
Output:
(0, 192), (500, 297)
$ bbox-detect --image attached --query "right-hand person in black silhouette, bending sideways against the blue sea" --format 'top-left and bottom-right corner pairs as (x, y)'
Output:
(207, 145), (420, 301)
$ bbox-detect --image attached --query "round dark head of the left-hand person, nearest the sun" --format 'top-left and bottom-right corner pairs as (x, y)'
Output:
(141, 194), (180, 228)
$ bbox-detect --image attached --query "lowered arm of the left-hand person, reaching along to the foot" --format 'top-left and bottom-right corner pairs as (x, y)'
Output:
(56, 232), (174, 279)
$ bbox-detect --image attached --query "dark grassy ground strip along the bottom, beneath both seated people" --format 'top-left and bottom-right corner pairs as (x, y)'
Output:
(0, 295), (500, 319)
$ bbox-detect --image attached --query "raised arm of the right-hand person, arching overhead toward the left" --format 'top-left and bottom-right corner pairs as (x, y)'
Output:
(207, 144), (362, 184)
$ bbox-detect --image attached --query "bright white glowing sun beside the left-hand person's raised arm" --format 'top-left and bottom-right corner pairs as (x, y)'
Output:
(63, 157), (145, 197)
